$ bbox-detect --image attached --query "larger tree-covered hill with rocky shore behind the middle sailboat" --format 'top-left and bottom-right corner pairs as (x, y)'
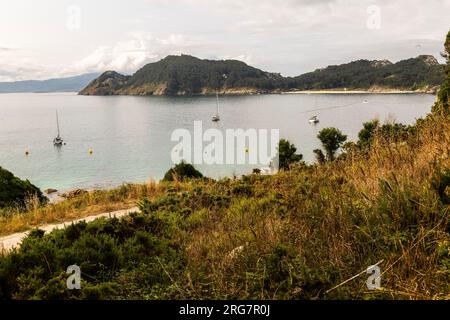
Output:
(80, 55), (285, 95)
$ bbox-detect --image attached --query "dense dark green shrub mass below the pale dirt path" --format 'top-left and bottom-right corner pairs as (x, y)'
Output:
(0, 209), (183, 299)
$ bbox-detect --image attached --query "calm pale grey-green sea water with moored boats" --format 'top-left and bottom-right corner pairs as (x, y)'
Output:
(0, 93), (435, 190)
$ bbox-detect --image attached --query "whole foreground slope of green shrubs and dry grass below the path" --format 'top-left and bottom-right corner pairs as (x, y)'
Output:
(0, 34), (450, 299)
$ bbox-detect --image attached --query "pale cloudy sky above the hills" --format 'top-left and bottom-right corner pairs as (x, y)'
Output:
(0, 0), (450, 81)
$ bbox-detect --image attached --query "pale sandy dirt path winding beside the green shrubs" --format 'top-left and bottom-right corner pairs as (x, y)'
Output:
(0, 208), (139, 253)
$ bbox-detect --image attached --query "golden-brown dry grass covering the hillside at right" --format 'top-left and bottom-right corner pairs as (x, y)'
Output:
(173, 115), (450, 299)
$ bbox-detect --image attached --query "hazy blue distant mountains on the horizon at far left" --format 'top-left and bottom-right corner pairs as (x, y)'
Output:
(0, 72), (100, 93)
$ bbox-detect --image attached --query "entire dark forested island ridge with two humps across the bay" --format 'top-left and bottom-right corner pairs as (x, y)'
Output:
(80, 55), (444, 95)
